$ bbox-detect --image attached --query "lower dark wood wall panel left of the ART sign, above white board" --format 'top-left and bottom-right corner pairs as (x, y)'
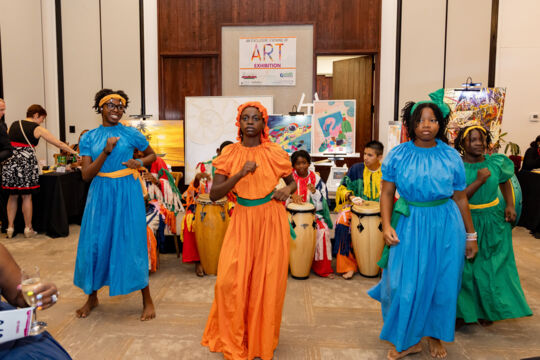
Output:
(159, 56), (218, 120)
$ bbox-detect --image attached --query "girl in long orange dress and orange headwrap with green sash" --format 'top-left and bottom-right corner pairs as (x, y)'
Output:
(202, 102), (296, 359)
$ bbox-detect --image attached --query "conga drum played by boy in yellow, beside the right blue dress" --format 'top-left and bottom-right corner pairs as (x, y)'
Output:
(351, 201), (384, 277)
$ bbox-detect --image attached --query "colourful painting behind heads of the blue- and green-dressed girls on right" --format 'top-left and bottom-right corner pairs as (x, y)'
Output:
(444, 87), (506, 150)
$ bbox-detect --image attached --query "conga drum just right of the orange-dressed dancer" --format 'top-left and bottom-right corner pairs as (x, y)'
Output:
(287, 203), (317, 280)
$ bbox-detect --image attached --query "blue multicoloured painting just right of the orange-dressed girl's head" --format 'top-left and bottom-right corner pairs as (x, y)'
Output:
(268, 115), (311, 154)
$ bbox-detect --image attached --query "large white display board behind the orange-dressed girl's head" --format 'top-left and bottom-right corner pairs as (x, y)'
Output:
(184, 95), (274, 184)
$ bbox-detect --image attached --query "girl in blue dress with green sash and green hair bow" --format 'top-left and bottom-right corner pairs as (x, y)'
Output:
(368, 89), (478, 359)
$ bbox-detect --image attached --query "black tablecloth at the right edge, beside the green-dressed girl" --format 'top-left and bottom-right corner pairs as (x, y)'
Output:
(517, 171), (540, 233)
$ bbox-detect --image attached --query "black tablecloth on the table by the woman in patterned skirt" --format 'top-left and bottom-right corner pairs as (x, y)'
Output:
(0, 171), (89, 237)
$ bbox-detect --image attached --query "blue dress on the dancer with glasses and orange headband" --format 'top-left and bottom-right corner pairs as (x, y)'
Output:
(74, 124), (148, 296)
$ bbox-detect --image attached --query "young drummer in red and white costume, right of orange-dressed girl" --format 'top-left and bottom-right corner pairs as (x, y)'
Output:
(291, 150), (334, 278)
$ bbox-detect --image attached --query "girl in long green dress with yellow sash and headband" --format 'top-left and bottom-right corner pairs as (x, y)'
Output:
(455, 126), (532, 325)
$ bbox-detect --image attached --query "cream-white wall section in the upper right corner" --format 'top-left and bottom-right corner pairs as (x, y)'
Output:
(495, 0), (540, 155)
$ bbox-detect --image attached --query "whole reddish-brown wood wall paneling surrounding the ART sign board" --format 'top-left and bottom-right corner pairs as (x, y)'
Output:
(158, 0), (382, 124)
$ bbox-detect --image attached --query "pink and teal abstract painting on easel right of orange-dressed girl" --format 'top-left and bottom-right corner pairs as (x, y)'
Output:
(312, 100), (356, 154)
